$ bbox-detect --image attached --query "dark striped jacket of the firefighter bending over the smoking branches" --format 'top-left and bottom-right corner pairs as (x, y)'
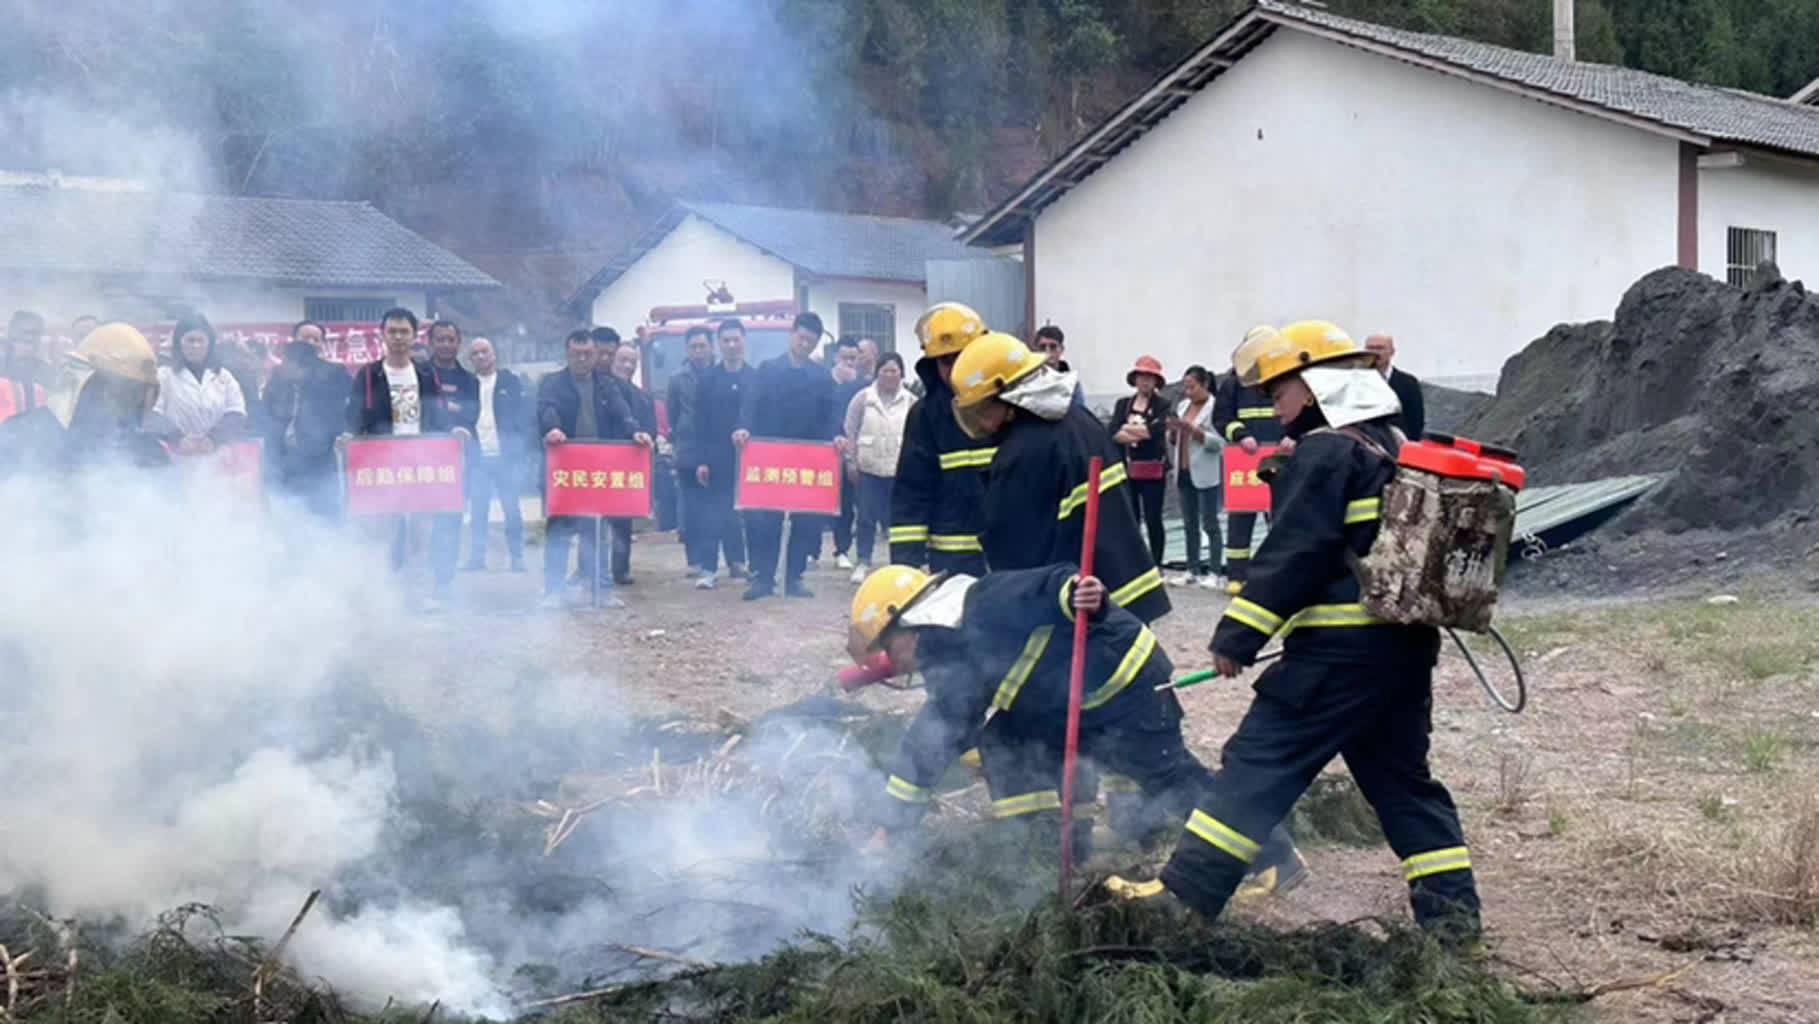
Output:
(879, 564), (1175, 828)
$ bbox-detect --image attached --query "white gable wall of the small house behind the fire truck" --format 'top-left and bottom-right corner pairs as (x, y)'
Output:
(593, 215), (795, 338)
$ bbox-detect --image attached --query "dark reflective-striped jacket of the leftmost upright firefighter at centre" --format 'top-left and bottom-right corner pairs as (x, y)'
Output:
(889, 356), (997, 566)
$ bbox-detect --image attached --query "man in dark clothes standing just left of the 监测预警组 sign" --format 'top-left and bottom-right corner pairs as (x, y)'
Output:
(677, 318), (757, 589)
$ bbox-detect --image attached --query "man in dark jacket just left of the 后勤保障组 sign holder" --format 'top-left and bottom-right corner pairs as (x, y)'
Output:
(262, 320), (347, 518)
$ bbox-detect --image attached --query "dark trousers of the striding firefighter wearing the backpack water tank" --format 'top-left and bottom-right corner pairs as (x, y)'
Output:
(1162, 655), (1479, 939)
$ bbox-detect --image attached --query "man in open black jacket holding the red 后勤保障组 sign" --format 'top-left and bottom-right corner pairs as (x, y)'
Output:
(342, 307), (471, 611)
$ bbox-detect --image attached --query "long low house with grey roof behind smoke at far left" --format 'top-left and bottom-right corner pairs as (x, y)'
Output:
(0, 175), (498, 352)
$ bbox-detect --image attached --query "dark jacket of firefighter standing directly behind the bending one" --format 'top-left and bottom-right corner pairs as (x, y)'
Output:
(982, 406), (1170, 622)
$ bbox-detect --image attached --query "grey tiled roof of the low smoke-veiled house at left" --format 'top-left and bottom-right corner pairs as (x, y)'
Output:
(0, 186), (498, 289)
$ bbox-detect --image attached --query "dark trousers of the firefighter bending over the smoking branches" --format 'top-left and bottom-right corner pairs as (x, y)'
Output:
(979, 693), (1295, 877)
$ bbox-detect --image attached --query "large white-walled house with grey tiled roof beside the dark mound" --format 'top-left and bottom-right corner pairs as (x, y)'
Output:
(964, 0), (1819, 393)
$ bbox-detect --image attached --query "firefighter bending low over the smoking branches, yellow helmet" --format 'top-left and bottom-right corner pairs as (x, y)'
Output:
(848, 564), (1297, 873)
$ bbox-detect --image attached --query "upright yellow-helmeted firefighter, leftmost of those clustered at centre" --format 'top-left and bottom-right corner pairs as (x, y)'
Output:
(889, 302), (995, 577)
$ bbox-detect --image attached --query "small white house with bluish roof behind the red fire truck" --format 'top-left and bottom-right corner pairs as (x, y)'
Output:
(569, 202), (984, 351)
